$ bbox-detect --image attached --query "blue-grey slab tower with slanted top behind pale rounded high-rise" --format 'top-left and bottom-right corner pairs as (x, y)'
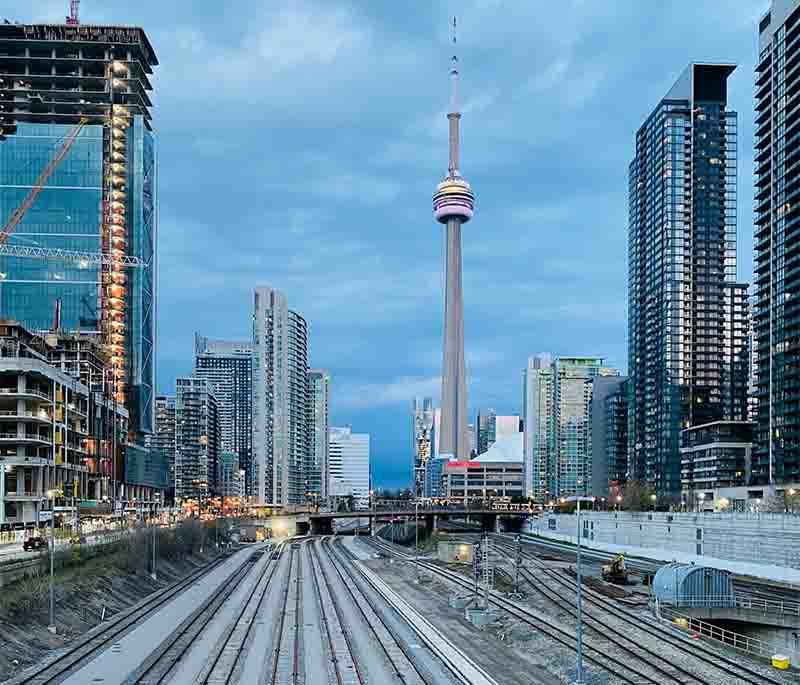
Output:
(194, 333), (253, 495)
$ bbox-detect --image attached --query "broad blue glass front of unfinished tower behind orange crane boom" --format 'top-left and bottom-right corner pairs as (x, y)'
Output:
(0, 123), (103, 331)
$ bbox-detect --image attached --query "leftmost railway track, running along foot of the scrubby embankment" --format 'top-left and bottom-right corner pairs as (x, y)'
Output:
(16, 557), (227, 685)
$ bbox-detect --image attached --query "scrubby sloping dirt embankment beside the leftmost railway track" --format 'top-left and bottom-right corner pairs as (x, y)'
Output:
(0, 556), (212, 682)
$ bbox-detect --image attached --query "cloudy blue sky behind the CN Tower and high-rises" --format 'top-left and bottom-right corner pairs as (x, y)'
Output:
(15, 0), (768, 486)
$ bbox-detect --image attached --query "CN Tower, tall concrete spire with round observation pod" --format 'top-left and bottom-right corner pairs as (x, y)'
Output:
(433, 17), (475, 459)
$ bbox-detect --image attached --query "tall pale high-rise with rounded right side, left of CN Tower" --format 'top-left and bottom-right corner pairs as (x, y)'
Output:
(253, 286), (311, 506)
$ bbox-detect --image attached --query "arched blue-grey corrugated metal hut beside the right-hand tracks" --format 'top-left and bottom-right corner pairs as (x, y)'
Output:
(652, 563), (736, 607)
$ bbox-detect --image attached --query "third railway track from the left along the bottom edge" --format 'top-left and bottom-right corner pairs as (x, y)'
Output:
(195, 544), (283, 685)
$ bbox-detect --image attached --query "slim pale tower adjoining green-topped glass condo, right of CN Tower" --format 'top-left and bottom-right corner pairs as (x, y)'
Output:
(522, 354), (555, 502)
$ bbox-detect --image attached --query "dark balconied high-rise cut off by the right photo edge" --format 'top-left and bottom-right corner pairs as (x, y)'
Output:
(751, 0), (800, 484)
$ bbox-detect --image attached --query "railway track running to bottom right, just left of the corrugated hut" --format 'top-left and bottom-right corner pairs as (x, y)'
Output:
(495, 539), (785, 685)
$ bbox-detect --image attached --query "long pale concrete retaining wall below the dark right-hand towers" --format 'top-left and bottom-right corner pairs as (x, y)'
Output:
(531, 512), (800, 583)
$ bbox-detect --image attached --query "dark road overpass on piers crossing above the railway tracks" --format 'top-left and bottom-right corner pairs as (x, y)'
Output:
(244, 506), (538, 535)
